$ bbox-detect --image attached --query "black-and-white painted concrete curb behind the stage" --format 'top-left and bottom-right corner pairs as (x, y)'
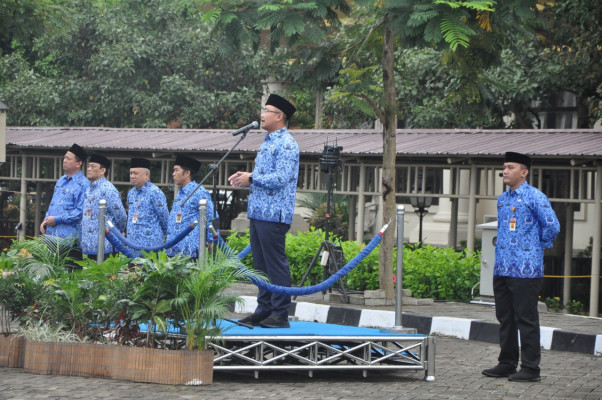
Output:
(235, 296), (602, 356)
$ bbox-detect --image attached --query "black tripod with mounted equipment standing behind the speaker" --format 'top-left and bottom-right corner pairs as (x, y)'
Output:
(293, 148), (349, 303)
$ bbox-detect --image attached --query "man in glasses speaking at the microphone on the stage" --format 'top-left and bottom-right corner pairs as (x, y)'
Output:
(228, 94), (299, 328)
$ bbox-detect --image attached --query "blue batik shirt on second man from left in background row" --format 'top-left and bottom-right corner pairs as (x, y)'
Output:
(81, 177), (127, 255)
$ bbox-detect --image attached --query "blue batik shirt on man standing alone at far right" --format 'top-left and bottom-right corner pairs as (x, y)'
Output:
(493, 182), (560, 278)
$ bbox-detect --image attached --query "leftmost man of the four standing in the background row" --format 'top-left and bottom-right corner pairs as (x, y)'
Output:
(40, 143), (89, 239)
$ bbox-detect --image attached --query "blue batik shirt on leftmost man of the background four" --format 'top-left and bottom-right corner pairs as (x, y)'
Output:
(46, 171), (90, 238)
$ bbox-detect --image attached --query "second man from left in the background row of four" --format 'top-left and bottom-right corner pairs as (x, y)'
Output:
(81, 154), (126, 256)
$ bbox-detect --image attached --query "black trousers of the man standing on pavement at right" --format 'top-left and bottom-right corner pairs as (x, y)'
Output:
(493, 276), (543, 371)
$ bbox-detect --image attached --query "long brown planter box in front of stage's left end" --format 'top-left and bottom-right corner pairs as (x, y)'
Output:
(24, 341), (213, 385)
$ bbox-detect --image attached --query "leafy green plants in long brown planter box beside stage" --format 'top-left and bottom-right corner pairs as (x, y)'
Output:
(6, 234), (262, 384)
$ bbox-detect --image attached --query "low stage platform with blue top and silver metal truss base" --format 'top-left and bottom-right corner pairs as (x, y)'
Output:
(210, 321), (435, 381)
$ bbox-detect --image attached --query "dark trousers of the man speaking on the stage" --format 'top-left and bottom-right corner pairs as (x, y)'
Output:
(250, 219), (291, 317)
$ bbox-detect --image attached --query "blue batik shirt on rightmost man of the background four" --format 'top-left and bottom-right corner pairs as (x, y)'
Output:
(166, 181), (213, 258)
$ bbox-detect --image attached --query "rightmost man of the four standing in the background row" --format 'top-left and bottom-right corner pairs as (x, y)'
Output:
(167, 155), (213, 258)
